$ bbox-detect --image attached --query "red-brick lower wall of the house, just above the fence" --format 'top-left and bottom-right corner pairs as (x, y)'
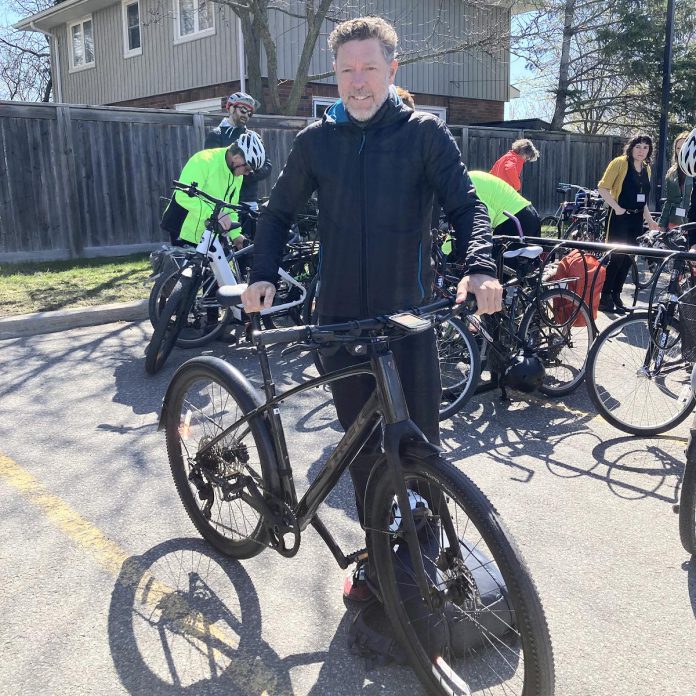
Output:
(109, 81), (505, 126)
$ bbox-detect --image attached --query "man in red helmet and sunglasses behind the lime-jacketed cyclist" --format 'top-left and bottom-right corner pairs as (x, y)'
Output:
(204, 92), (272, 239)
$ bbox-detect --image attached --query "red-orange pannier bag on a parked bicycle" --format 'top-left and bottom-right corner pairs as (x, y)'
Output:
(551, 249), (607, 326)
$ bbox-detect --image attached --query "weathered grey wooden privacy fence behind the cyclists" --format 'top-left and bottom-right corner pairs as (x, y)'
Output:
(0, 102), (615, 261)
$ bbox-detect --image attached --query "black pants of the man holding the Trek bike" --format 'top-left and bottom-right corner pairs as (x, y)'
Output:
(321, 324), (442, 525)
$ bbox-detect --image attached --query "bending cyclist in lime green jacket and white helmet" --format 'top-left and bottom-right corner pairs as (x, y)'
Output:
(161, 131), (265, 248)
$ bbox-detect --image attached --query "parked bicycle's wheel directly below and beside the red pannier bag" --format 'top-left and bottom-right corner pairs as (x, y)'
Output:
(520, 288), (594, 396)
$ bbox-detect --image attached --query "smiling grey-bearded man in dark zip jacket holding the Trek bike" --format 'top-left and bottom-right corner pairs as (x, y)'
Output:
(242, 17), (502, 590)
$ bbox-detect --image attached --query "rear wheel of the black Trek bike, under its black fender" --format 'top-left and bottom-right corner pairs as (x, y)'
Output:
(163, 357), (277, 558)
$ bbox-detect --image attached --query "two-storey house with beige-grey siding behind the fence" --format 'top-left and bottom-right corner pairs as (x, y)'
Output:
(15, 0), (515, 125)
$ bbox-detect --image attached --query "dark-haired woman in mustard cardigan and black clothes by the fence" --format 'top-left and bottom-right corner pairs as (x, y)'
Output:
(597, 133), (659, 314)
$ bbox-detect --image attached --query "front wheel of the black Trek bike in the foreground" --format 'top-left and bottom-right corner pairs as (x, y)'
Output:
(368, 455), (554, 696)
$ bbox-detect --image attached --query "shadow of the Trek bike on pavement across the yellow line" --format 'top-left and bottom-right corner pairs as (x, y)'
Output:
(108, 538), (406, 696)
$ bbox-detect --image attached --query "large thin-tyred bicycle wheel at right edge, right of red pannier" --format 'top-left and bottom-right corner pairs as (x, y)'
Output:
(586, 312), (696, 436)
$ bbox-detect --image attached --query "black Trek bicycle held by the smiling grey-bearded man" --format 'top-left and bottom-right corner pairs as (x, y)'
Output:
(160, 287), (554, 696)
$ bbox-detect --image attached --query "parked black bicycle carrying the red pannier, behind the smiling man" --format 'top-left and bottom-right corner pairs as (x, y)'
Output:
(434, 223), (595, 420)
